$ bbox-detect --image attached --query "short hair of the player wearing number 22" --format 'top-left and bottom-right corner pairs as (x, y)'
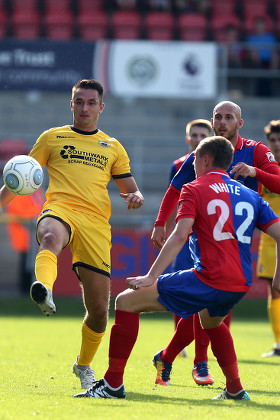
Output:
(195, 136), (234, 171)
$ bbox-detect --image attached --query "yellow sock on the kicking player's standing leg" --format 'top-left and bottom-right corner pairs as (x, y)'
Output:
(78, 322), (105, 366)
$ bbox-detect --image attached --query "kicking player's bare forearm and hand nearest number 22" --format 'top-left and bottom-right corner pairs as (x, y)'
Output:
(114, 176), (144, 210)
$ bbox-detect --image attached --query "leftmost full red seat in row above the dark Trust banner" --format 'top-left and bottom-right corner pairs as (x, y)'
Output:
(11, 8), (41, 39)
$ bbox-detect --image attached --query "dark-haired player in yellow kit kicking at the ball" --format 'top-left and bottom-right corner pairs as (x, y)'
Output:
(0, 79), (144, 389)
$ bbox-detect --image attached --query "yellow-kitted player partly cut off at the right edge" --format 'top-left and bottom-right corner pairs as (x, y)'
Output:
(257, 120), (280, 357)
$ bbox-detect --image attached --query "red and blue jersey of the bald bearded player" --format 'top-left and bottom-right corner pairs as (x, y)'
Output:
(171, 136), (280, 193)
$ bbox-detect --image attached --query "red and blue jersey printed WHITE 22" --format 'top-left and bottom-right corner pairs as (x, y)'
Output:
(176, 170), (279, 292)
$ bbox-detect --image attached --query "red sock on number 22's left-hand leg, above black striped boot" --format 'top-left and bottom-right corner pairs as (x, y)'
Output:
(104, 309), (139, 388)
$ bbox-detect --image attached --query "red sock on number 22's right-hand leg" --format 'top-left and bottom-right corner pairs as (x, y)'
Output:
(205, 322), (243, 394)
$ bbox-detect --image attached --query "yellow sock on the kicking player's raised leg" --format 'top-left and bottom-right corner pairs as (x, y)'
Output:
(35, 249), (57, 292)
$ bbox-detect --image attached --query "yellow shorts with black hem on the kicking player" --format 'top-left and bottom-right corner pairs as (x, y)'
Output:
(37, 204), (112, 277)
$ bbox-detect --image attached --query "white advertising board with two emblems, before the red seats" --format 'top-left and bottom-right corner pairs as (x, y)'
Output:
(98, 41), (217, 99)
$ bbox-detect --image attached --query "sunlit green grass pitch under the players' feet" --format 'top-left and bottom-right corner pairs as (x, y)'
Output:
(0, 299), (280, 420)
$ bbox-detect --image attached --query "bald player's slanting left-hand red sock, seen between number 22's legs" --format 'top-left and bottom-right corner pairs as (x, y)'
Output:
(160, 316), (193, 363)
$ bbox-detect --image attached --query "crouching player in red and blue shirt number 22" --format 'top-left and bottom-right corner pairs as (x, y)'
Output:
(76, 136), (280, 400)
